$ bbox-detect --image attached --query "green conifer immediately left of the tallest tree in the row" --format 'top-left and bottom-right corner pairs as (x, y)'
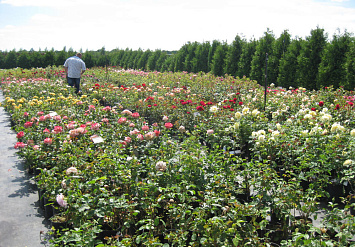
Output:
(277, 39), (305, 88)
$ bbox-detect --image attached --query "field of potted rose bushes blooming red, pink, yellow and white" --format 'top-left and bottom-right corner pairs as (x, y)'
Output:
(0, 67), (355, 247)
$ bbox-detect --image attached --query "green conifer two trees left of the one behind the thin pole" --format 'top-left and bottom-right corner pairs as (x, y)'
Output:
(224, 35), (246, 76)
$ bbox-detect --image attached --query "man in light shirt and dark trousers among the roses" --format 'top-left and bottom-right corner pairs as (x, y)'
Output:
(64, 53), (86, 94)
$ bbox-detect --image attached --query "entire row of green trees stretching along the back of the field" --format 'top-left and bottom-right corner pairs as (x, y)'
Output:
(0, 27), (355, 90)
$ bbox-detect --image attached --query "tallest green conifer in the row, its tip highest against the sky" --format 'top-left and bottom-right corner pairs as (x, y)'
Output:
(297, 27), (327, 90)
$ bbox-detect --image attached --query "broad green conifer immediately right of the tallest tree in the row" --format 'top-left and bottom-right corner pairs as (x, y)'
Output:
(317, 29), (351, 89)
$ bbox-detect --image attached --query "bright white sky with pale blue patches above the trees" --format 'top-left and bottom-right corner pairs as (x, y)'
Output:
(0, 0), (355, 51)
